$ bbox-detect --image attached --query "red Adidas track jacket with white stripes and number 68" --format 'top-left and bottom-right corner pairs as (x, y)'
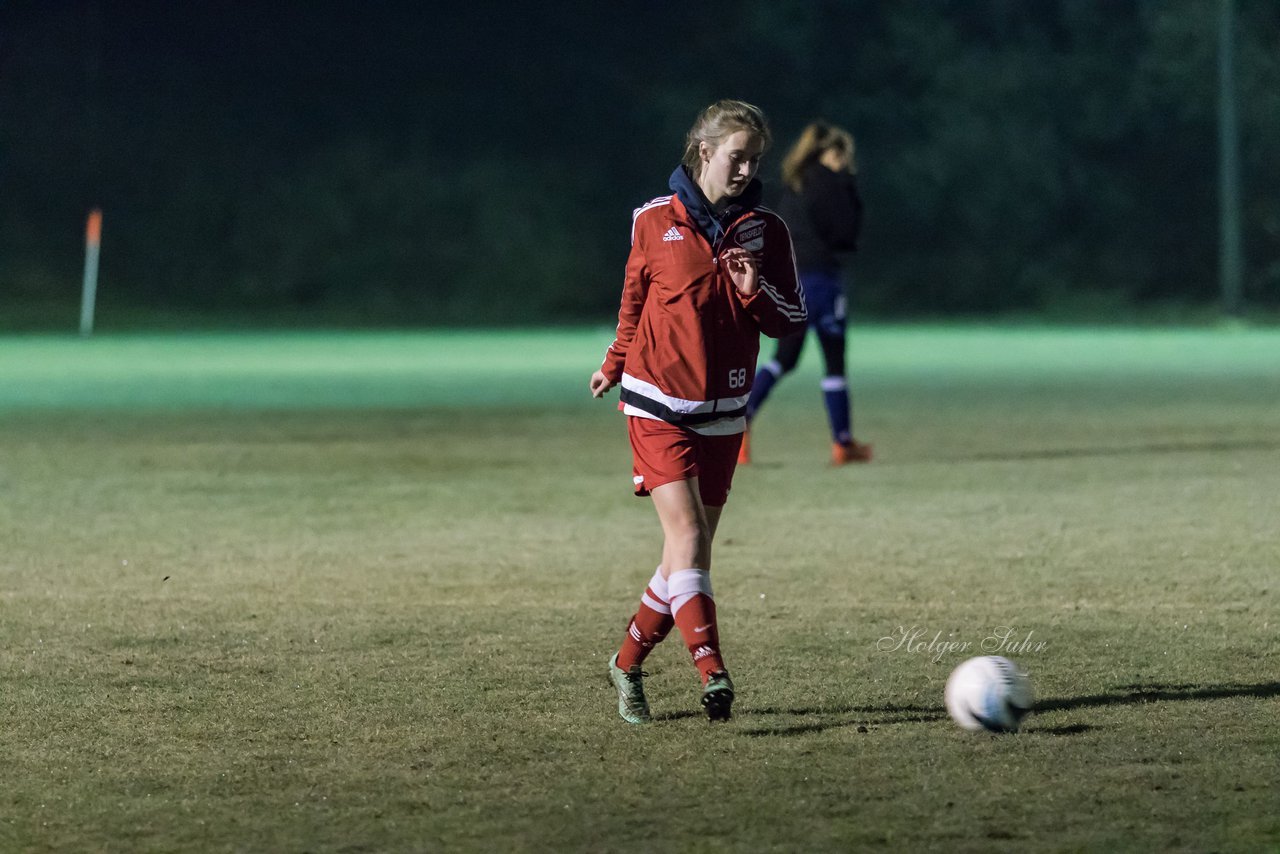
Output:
(600, 186), (808, 434)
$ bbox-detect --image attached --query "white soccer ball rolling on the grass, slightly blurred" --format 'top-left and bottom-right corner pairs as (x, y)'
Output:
(943, 656), (1036, 732)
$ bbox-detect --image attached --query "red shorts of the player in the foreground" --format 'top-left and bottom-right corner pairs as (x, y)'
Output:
(627, 415), (742, 507)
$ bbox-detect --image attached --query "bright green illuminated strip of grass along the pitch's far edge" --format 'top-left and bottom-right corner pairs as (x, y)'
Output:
(0, 326), (1280, 411)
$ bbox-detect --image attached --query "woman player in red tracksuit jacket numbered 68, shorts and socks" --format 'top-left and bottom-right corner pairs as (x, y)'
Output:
(590, 101), (806, 723)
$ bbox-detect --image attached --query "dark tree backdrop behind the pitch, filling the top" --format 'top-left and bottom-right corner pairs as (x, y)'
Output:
(0, 0), (1280, 323)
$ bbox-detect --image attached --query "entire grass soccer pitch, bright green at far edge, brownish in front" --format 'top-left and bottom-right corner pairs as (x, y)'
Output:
(0, 326), (1280, 851)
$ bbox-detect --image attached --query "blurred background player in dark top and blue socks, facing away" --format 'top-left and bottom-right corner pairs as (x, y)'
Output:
(739, 122), (872, 466)
